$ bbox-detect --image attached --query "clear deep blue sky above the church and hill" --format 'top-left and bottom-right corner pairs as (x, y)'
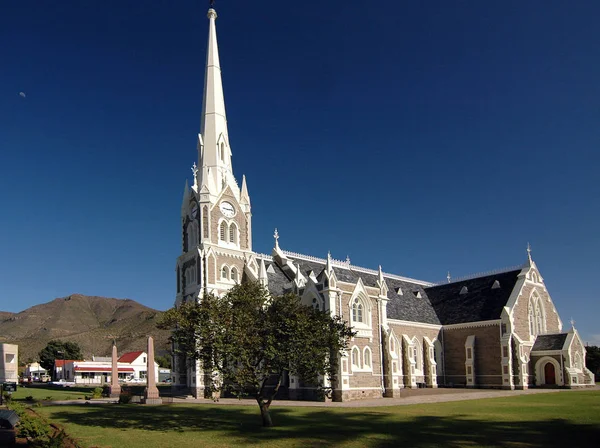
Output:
(0, 0), (600, 343)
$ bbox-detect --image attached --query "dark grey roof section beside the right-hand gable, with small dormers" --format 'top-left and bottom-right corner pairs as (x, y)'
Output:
(425, 269), (521, 325)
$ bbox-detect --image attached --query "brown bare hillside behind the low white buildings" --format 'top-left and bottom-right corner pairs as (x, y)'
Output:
(0, 294), (169, 362)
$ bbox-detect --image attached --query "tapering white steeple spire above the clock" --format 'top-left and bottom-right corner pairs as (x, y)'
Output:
(198, 8), (233, 195)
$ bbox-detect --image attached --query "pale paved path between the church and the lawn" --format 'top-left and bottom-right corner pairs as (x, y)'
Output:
(45, 386), (600, 408)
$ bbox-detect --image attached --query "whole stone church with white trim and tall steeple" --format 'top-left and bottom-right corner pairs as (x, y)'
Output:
(173, 7), (595, 401)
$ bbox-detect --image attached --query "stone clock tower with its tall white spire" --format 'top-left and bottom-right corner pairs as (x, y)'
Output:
(173, 8), (252, 396)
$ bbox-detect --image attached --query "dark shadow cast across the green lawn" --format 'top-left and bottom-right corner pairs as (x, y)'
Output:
(43, 405), (600, 448)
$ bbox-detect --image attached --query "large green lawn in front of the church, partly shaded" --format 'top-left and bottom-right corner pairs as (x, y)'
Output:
(37, 391), (600, 448)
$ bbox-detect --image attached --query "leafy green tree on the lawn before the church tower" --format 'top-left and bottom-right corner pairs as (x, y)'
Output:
(159, 282), (355, 426)
